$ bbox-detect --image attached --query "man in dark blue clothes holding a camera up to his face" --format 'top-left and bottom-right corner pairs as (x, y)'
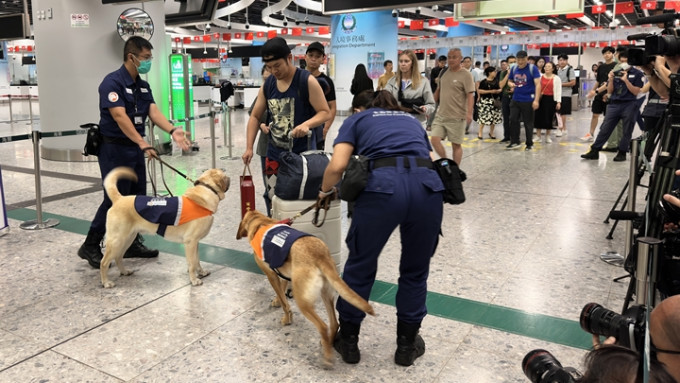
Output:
(581, 52), (644, 162)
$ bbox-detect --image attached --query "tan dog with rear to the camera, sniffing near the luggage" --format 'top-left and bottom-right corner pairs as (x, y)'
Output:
(236, 210), (375, 367)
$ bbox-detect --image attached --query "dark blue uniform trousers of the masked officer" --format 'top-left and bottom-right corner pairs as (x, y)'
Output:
(90, 142), (146, 233)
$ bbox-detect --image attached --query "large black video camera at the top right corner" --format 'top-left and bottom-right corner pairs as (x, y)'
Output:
(628, 13), (680, 66)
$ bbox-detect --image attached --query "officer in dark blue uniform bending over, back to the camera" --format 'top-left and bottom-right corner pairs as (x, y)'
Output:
(319, 90), (444, 366)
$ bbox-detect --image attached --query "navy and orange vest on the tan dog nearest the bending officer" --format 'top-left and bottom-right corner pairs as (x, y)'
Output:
(250, 223), (311, 279)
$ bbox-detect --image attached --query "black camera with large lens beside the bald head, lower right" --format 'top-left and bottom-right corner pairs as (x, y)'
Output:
(579, 303), (645, 352)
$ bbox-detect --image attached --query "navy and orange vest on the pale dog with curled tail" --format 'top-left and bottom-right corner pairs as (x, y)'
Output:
(135, 195), (213, 237)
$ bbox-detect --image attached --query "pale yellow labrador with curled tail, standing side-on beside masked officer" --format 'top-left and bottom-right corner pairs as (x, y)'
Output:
(99, 167), (229, 288)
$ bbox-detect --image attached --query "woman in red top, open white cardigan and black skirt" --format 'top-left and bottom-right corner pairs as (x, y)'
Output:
(534, 61), (562, 143)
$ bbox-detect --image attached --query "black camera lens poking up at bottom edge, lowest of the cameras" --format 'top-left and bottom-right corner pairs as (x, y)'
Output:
(522, 349), (583, 383)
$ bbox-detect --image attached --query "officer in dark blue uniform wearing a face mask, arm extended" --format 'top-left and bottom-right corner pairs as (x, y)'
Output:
(78, 36), (189, 269)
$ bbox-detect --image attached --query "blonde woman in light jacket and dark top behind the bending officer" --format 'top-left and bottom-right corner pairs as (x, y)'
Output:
(385, 50), (434, 122)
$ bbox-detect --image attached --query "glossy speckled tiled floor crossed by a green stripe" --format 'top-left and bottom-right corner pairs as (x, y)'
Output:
(0, 100), (644, 382)
